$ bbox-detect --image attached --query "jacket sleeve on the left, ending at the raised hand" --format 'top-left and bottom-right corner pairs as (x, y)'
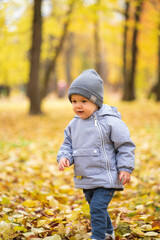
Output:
(57, 127), (73, 165)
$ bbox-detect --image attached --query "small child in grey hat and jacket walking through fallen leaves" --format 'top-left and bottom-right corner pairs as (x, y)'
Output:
(57, 69), (135, 240)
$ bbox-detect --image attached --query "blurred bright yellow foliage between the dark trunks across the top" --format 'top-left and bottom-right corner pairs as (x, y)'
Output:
(0, 0), (159, 94)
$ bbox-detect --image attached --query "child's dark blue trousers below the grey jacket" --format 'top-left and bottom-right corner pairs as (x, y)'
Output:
(83, 188), (115, 240)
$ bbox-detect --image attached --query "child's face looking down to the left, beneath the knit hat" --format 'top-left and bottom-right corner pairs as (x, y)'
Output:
(71, 94), (98, 119)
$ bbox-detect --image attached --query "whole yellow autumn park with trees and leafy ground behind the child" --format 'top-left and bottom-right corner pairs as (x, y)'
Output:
(0, 0), (160, 240)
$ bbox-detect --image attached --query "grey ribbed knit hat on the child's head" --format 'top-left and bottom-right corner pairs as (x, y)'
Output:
(68, 69), (103, 107)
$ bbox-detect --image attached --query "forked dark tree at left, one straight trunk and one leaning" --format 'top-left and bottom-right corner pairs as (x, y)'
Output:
(27, 0), (74, 114)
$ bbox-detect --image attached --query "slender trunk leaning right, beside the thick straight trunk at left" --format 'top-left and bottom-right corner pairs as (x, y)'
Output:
(41, 0), (74, 98)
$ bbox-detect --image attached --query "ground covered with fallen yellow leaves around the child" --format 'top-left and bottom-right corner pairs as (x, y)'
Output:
(0, 98), (160, 240)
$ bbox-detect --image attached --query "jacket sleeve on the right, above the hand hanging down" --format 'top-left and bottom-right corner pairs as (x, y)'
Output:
(111, 118), (135, 173)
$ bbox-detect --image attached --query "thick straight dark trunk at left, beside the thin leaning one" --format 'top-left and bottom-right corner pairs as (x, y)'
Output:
(27, 0), (42, 114)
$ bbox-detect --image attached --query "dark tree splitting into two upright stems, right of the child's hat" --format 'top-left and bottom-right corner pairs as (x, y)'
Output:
(123, 0), (143, 101)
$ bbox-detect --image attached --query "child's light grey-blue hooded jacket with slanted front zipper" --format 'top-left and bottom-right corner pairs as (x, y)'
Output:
(57, 105), (135, 190)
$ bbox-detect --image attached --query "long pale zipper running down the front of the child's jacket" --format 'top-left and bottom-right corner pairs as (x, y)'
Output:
(94, 116), (114, 188)
